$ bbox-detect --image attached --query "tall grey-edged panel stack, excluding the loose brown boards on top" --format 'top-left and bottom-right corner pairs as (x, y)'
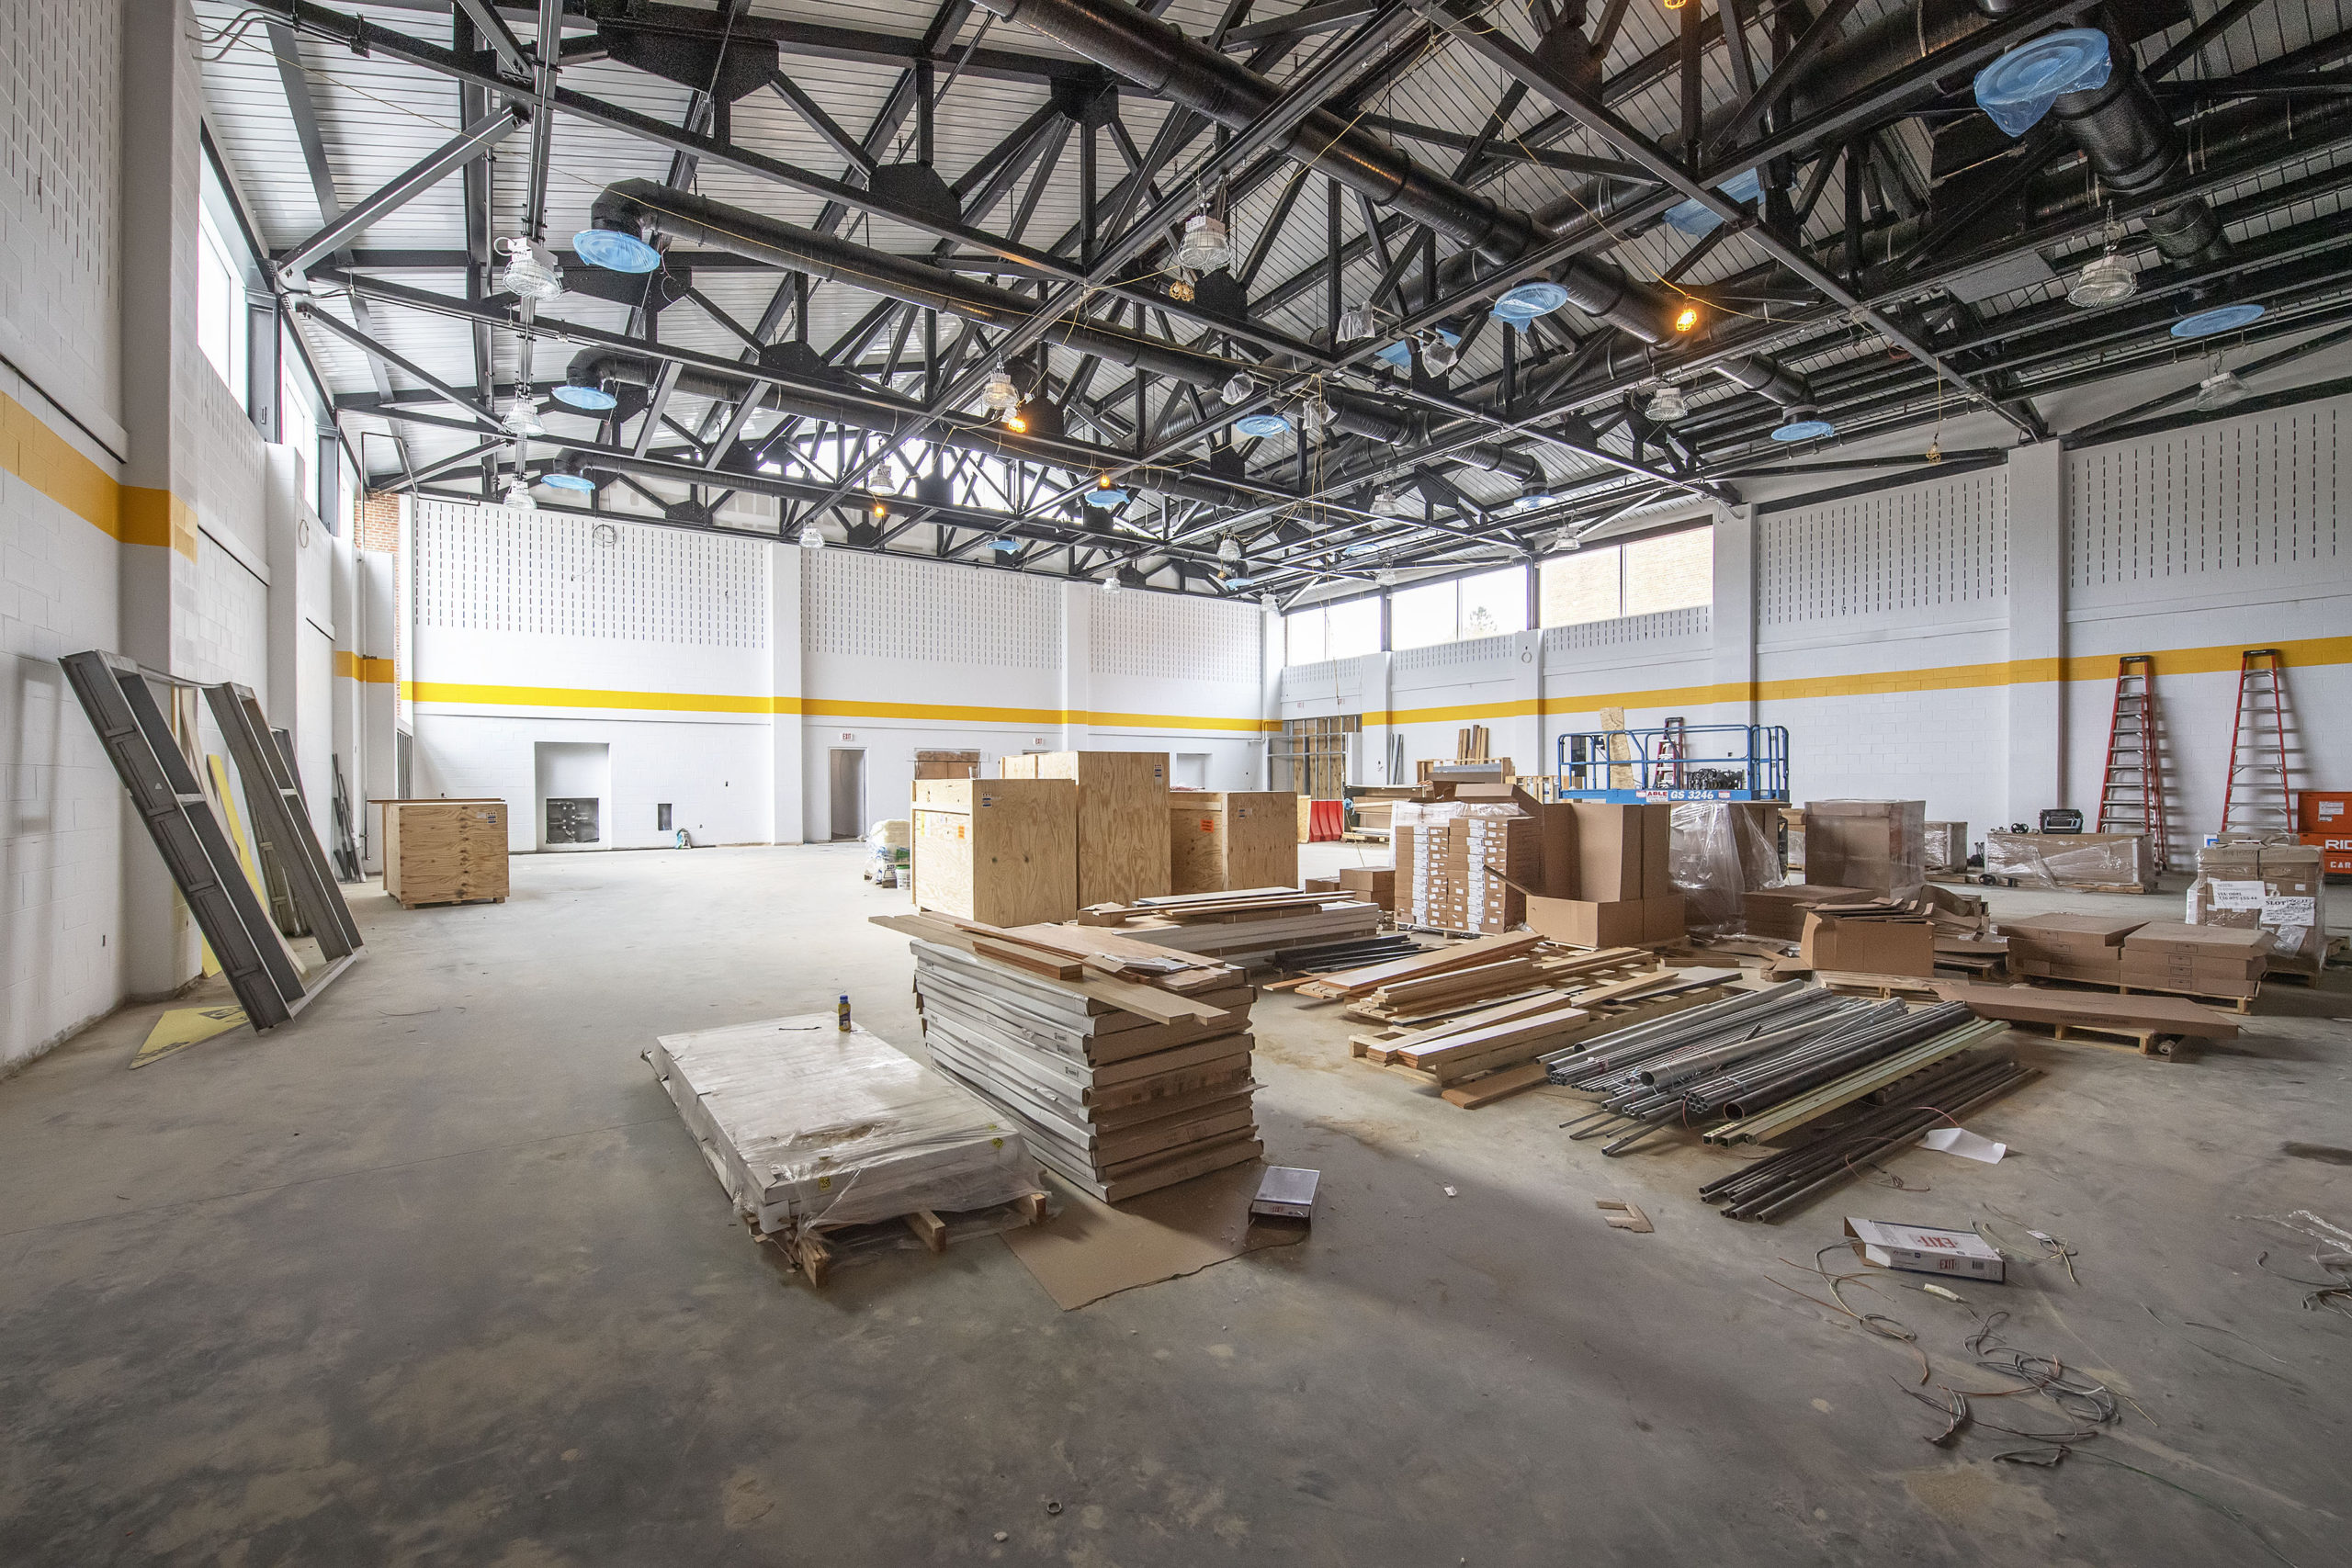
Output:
(912, 938), (1263, 1201)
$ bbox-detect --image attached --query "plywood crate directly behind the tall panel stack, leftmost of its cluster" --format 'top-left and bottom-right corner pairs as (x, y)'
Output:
(912, 778), (1077, 926)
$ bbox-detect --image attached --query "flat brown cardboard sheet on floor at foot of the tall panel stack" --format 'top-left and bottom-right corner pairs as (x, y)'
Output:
(1004, 1159), (1307, 1312)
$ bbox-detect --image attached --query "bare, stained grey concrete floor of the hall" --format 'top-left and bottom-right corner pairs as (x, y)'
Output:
(0, 846), (2352, 1568)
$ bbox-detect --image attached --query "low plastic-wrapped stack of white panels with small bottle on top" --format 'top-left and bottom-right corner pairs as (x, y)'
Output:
(647, 1013), (1037, 1232)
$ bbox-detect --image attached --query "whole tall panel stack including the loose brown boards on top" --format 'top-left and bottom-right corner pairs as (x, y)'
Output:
(875, 915), (1263, 1201)
